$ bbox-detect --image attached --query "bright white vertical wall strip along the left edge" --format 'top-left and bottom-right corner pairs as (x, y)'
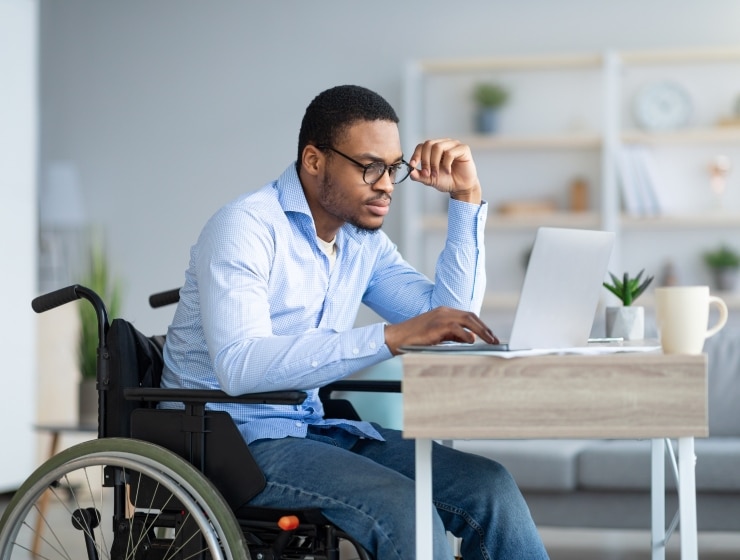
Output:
(0, 0), (38, 492)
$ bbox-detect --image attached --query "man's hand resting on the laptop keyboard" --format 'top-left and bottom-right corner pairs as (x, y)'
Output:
(385, 307), (499, 356)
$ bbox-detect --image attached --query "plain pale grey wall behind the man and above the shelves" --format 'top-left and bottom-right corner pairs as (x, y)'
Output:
(41, 0), (740, 331)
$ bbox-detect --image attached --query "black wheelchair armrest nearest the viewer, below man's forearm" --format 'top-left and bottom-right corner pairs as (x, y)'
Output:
(123, 387), (306, 404)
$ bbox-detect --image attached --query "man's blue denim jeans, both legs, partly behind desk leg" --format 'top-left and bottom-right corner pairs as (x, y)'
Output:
(249, 425), (548, 560)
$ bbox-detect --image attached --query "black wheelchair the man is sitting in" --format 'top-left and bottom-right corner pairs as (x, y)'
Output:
(0, 285), (400, 560)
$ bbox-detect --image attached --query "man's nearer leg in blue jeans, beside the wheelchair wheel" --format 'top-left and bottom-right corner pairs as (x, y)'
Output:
(249, 438), (449, 559)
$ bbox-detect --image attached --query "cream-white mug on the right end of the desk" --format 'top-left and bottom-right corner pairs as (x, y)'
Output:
(655, 286), (727, 354)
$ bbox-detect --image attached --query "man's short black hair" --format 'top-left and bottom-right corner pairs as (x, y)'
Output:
(296, 85), (398, 166)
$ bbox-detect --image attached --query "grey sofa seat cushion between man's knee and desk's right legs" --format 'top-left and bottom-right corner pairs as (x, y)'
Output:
(454, 439), (590, 492)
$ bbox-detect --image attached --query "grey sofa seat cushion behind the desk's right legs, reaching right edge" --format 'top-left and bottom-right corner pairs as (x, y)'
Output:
(578, 437), (740, 492)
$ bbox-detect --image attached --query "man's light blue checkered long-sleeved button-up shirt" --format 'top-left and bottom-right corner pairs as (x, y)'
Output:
(162, 164), (488, 442)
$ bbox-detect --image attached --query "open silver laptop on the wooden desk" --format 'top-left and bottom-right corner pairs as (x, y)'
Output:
(401, 227), (615, 352)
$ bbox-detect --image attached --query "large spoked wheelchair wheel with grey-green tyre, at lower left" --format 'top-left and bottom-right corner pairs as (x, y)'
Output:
(0, 438), (250, 560)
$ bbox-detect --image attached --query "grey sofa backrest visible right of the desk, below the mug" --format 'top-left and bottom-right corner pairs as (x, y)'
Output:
(704, 325), (740, 436)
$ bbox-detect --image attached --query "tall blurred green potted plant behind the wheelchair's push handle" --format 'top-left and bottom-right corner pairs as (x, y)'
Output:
(77, 238), (122, 426)
